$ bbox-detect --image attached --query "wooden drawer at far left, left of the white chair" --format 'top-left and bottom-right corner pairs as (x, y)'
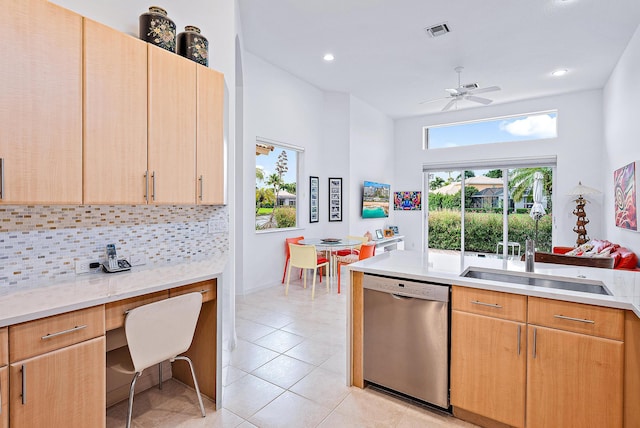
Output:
(9, 306), (104, 362)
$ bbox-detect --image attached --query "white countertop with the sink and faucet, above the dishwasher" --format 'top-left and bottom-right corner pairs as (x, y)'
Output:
(348, 251), (640, 317)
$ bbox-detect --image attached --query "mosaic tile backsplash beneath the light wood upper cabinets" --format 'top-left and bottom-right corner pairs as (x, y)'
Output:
(0, 205), (229, 286)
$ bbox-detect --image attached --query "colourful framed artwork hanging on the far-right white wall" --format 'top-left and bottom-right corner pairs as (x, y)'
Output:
(613, 162), (638, 231)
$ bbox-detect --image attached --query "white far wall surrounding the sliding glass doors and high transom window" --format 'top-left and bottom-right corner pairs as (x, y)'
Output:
(395, 90), (605, 249)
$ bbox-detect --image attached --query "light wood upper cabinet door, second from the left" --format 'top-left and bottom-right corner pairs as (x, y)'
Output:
(84, 18), (147, 204)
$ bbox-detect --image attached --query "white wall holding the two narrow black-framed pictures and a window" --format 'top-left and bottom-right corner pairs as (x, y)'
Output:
(237, 52), (393, 294)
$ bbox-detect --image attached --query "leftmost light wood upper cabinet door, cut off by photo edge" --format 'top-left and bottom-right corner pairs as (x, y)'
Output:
(0, 0), (82, 204)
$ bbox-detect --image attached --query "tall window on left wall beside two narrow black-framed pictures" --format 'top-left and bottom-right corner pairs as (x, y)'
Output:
(256, 138), (302, 231)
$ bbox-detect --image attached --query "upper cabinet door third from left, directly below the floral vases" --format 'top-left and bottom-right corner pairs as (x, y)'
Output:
(148, 45), (196, 204)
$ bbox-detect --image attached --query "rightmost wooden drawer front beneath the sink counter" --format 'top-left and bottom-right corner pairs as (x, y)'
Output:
(529, 297), (624, 340)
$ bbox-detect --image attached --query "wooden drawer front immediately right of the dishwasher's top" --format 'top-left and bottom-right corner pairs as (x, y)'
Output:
(451, 285), (527, 322)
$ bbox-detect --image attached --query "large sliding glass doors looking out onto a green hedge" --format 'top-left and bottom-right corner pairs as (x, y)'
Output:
(424, 158), (556, 259)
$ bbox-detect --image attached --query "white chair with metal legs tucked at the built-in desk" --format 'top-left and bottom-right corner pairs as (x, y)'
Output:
(107, 293), (206, 428)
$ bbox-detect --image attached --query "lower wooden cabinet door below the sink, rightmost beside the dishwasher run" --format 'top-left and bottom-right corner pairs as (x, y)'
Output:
(527, 326), (624, 428)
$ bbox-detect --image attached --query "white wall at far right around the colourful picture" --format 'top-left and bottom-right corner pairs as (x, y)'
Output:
(600, 23), (640, 254)
